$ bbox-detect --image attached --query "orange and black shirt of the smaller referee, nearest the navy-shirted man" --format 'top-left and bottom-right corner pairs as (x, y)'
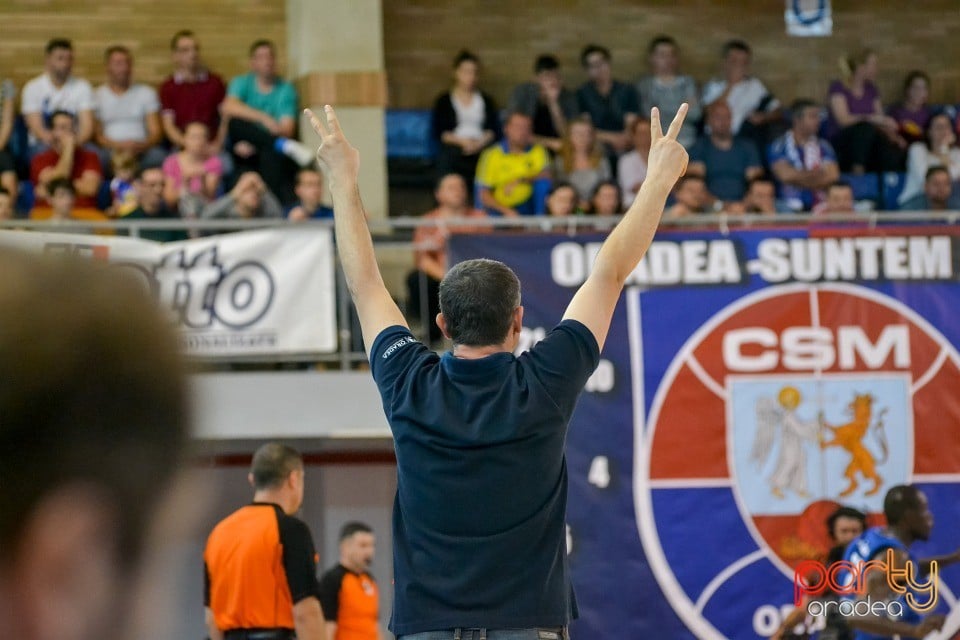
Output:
(320, 564), (380, 640)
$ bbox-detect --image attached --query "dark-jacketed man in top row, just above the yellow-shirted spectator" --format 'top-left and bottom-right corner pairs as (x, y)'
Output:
(507, 55), (580, 152)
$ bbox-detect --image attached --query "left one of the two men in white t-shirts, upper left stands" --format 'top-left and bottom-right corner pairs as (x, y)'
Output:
(20, 38), (95, 152)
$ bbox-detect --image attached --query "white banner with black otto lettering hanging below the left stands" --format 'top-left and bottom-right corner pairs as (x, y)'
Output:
(0, 227), (337, 357)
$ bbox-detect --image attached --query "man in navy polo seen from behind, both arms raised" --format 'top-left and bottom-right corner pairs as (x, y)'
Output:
(309, 105), (687, 640)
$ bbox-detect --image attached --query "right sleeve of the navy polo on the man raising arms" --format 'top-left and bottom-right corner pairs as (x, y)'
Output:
(520, 320), (600, 414)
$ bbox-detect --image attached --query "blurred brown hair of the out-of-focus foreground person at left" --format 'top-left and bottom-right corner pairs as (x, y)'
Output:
(0, 249), (188, 566)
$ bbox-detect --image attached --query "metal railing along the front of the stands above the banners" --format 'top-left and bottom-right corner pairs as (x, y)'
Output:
(0, 211), (960, 369)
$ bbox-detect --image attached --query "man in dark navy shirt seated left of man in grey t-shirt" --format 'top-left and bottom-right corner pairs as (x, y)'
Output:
(577, 44), (640, 155)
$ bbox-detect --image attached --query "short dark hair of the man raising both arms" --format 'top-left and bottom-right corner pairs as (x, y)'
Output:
(440, 259), (520, 347)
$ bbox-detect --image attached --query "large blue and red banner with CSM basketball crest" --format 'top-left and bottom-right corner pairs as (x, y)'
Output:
(450, 226), (960, 639)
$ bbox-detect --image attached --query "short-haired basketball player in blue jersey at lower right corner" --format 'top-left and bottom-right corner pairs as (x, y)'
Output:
(841, 485), (960, 640)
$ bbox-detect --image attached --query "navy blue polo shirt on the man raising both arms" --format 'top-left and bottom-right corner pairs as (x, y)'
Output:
(370, 320), (600, 636)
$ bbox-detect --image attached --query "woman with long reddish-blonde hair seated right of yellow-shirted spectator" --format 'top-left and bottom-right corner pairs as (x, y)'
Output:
(554, 116), (613, 210)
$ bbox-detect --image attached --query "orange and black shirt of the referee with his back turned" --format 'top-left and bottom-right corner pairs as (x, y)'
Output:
(203, 502), (319, 631)
